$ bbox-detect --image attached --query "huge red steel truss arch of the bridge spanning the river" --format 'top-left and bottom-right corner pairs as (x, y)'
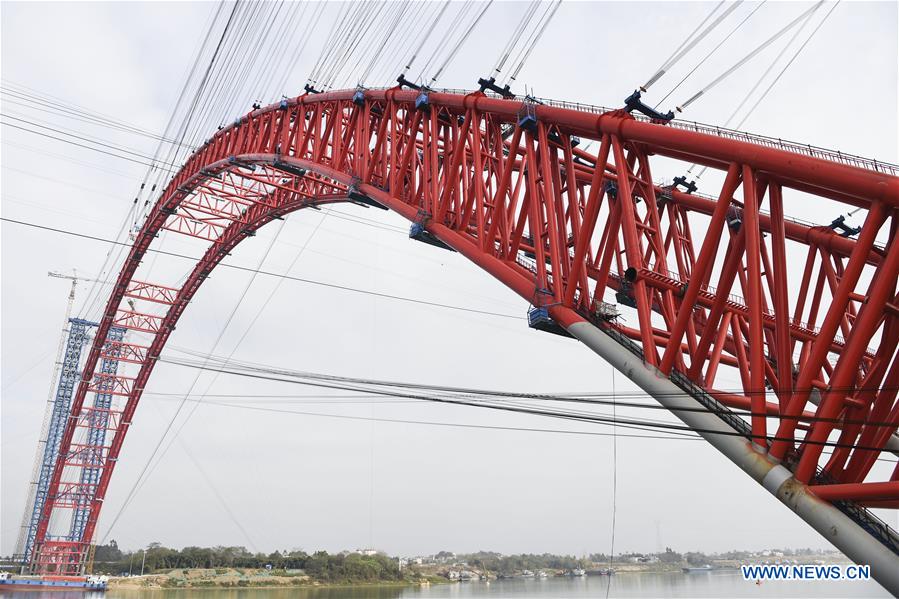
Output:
(32, 89), (899, 584)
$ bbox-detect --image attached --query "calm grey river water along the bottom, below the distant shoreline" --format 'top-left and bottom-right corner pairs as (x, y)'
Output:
(0, 570), (890, 599)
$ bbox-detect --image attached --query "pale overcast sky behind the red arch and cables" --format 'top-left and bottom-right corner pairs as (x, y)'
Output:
(0, 1), (897, 554)
